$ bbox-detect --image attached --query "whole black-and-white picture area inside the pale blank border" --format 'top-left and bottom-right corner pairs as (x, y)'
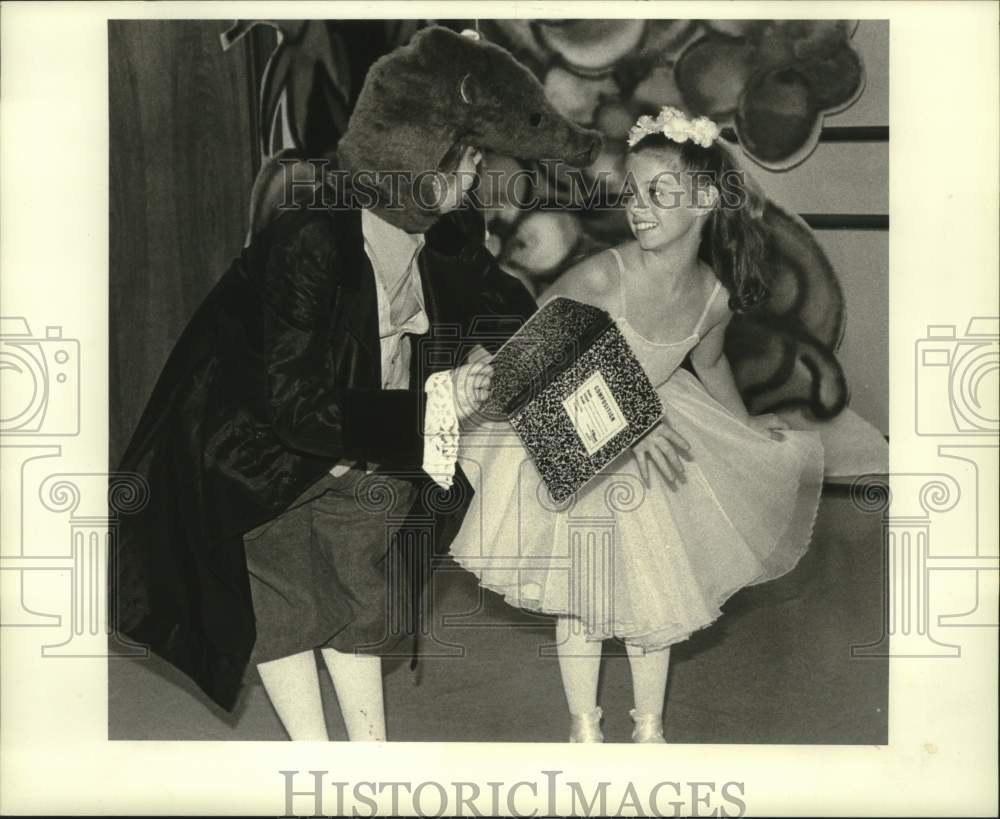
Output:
(107, 18), (892, 745)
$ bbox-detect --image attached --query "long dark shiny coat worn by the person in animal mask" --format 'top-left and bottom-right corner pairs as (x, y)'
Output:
(109, 203), (535, 709)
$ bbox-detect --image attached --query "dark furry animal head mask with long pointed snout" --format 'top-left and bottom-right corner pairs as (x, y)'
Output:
(337, 27), (600, 232)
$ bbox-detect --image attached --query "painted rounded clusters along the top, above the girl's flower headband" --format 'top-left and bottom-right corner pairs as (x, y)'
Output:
(481, 20), (864, 169)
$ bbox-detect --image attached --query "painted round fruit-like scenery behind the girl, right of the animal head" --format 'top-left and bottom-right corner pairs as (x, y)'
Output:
(480, 20), (864, 419)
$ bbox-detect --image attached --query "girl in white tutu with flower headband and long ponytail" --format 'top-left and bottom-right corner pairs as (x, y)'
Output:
(451, 108), (823, 742)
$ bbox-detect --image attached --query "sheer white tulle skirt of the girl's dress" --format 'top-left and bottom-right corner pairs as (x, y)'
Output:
(451, 370), (823, 648)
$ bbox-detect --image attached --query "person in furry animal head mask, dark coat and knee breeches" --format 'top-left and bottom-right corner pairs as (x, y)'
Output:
(110, 27), (599, 739)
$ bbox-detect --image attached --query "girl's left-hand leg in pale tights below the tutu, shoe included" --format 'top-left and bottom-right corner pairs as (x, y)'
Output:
(556, 617), (604, 742)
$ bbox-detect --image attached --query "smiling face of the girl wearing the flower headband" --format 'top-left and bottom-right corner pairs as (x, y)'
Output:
(625, 151), (711, 250)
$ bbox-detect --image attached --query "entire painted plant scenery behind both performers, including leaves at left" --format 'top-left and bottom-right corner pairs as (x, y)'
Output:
(224, 20), (864, 419)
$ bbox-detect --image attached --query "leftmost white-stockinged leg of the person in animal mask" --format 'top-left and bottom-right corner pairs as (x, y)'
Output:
(257, 650), (330, 742)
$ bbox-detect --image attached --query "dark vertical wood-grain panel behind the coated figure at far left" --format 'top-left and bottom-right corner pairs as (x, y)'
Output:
(108, 20), (256, 465)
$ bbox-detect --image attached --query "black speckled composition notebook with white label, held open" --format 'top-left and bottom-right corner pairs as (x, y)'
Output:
(483, 297), (663, 502)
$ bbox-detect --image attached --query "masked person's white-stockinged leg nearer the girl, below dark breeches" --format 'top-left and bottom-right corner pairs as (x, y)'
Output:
(321, 648), (385, 742)
